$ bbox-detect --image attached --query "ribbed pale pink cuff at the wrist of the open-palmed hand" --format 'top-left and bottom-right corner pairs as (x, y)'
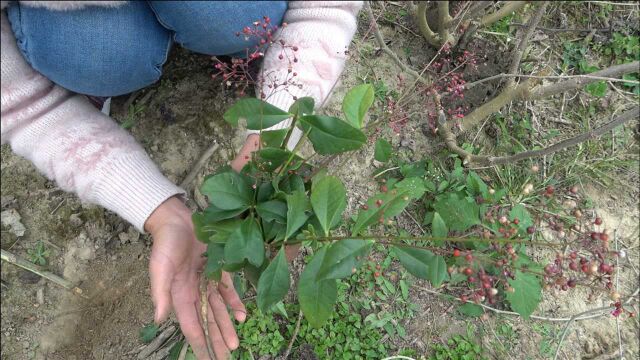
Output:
(90, 153), (185, 233)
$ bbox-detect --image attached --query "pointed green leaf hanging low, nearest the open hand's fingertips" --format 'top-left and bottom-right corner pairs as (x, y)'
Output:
(257, 246), (290, 313)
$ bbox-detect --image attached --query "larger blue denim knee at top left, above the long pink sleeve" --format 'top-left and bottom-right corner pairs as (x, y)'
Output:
(8, 1), (172, 96)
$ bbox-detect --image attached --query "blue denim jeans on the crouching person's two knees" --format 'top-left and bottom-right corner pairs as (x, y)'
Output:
(7, 1), (287, 96)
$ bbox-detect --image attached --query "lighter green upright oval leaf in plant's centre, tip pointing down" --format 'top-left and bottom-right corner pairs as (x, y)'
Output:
(311, 176), (347, 236)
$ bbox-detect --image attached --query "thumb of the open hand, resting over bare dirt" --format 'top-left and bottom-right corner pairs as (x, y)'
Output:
(149, 251), (175, 324)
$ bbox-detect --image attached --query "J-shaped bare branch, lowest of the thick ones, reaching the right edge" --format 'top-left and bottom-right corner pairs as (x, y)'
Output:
(438, 106), (640, 166)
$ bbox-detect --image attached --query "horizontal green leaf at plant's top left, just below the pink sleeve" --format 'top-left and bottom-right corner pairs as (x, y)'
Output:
(222, 98), (291, 130)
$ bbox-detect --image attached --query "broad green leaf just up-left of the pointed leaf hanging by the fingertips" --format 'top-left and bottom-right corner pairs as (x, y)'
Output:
(224, 218), (264, 266)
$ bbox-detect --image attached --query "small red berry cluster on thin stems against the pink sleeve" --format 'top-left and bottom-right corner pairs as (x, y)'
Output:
(212, 16), (302, 100)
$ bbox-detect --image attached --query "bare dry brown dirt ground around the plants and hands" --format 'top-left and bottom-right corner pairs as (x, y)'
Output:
(0, 1), (639, 359)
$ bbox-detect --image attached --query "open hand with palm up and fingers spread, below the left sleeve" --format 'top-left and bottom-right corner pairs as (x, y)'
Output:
(145, 197), (246, 360)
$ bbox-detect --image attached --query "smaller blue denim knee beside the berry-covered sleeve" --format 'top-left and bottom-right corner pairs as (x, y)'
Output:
(149, 1), (287, 56)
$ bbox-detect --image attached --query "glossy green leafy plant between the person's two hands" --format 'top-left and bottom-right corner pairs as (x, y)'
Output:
(193, 84), (447, 328)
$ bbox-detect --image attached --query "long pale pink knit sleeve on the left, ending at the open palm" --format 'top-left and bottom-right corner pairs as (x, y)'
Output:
(0, 11), (183, 231)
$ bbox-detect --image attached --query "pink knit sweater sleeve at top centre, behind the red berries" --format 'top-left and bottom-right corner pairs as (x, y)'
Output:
(248, 1), (362, 148)
